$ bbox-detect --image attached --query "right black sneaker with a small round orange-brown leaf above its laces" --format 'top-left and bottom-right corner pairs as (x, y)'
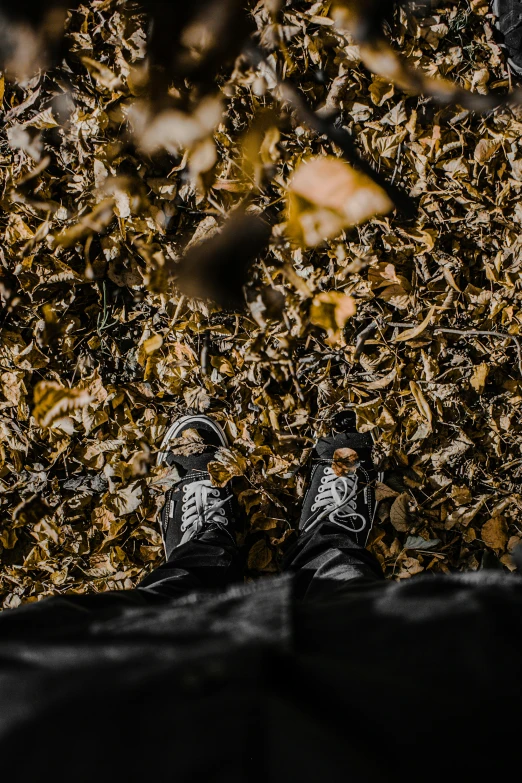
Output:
(299, 412), (382, 546)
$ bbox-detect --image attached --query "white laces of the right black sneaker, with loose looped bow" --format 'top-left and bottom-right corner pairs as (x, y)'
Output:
(306, 468), (367, 533)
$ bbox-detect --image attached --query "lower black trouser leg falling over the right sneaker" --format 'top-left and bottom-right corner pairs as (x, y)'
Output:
(283, 522), (383, 599)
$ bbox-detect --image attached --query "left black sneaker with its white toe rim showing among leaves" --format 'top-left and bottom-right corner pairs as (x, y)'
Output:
(158, 415), (236, 558)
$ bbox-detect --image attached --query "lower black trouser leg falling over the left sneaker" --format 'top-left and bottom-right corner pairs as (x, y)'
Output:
(138, 530), (242, 597)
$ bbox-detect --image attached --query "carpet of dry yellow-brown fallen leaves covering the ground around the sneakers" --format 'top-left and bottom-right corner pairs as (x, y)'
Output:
(0, 0), (522, 607)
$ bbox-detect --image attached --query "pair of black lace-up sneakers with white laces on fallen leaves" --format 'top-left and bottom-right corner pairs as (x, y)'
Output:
(158, 413), (379, 558)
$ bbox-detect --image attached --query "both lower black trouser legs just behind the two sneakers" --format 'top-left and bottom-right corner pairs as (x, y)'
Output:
(139, 522), (382, 599)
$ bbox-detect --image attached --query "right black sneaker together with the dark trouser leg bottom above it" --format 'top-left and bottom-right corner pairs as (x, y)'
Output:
(283, 415), (383, 600)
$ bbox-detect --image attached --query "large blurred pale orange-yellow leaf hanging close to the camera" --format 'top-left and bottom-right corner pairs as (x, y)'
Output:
(288, 156), (393, 245)
